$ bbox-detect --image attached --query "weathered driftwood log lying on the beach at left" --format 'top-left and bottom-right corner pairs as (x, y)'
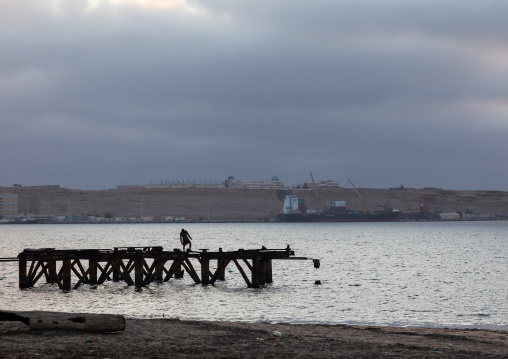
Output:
(0, 310), (125, 332)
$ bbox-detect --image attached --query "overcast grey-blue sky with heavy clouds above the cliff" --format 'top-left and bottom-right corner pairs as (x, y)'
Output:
(0, 0), (508, 191)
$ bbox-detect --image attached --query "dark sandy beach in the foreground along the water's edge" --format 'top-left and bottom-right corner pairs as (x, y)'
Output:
(0, 319), (508, 359)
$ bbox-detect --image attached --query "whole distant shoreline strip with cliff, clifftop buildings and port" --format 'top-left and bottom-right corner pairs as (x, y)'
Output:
(0, 174), (508, 223)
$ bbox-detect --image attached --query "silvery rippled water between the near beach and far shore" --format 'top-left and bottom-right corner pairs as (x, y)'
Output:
(0, 222), (508, 330)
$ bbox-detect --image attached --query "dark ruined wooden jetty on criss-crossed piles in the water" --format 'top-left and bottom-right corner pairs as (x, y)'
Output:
(7, 245), (315, 291)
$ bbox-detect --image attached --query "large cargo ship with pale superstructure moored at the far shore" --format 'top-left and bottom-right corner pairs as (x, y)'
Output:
(278, 194), (399, 222)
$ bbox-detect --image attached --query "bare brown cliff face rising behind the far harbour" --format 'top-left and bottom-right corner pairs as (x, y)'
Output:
(0, 187), (508, 221)
